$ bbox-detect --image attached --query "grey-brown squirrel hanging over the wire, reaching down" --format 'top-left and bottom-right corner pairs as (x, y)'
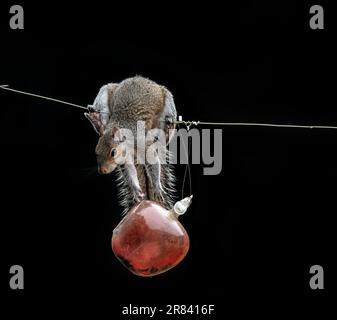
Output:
(85, 76), (177, 213)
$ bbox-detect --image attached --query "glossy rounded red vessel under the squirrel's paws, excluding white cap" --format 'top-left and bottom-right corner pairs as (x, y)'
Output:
(111, 200), (189, 277)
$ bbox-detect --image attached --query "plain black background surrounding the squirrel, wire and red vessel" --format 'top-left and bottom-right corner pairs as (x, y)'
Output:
(0, 1), (337, 319)
